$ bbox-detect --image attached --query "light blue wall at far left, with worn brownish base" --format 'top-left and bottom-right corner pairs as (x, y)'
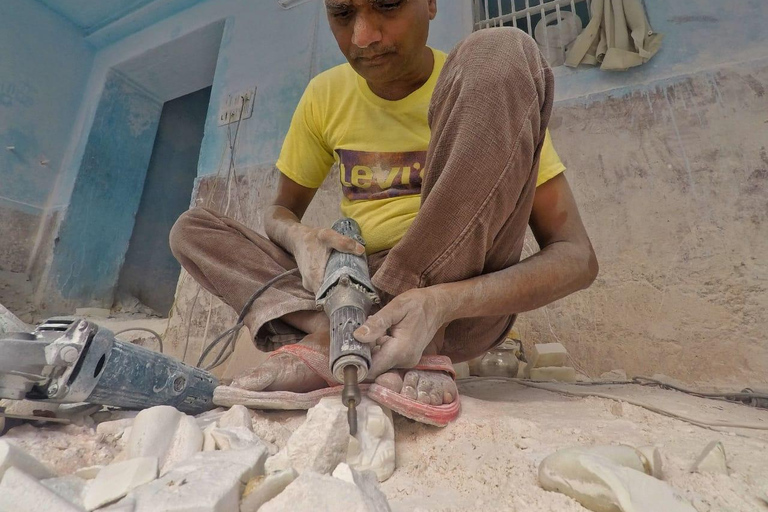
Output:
(0, 0), (93, 272)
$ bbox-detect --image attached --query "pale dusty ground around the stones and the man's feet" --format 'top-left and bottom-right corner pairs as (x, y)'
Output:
(0, 286), (768, 512)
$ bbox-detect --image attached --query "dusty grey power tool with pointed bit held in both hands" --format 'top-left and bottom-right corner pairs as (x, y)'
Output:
(316, 218), (379, 435)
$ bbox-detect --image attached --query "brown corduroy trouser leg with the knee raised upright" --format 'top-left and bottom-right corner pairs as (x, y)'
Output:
(373, 28), (554, 361)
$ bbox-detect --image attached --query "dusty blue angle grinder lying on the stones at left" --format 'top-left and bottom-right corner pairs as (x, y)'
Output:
(0, 317), (219, 414)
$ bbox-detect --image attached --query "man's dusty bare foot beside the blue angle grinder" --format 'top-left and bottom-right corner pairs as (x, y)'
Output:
(232, 331), (329, 393)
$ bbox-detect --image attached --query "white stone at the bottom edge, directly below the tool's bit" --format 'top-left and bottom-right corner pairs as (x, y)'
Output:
(259, 471), (390, 512)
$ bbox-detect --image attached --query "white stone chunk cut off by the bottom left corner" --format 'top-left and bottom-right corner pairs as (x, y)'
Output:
(0, 467), (82, 512)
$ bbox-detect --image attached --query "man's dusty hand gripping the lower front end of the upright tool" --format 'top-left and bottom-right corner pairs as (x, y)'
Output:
(354, 288), (444, 379)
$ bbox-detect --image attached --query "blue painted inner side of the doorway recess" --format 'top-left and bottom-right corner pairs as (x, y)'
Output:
(51, 72), (162, 307)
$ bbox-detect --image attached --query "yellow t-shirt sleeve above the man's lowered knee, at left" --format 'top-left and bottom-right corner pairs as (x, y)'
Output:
(277, 82), (334, 188)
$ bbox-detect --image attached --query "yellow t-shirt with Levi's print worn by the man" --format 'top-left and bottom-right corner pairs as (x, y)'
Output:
(277, 50), (565, 254)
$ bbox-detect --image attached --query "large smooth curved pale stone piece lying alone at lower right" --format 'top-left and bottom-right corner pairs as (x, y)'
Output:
(539, 449), (696, 512)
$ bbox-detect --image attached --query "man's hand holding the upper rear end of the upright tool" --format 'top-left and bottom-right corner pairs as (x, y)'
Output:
(290, 226), (365, 293)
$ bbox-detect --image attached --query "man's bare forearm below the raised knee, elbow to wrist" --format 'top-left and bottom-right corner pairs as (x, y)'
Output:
(432, 242), (597, 323)
